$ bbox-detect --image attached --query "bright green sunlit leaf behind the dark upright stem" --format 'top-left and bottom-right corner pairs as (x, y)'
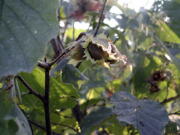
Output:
(19, 68), (79, 110)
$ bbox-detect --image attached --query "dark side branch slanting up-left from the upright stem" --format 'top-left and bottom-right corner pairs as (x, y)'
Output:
(15, 75), (44, 101)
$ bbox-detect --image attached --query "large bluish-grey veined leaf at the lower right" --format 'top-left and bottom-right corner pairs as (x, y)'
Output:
(111, 91), (168, 135)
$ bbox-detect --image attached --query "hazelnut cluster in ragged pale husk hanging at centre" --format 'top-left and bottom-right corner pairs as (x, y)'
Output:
(68, 34), (127, 67)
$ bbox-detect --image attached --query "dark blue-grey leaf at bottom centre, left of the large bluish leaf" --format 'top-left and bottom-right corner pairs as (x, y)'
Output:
(81, 107), (112, 135)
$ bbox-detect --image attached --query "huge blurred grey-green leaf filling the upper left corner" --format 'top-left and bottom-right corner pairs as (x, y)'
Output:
(0, 0), (58, 77)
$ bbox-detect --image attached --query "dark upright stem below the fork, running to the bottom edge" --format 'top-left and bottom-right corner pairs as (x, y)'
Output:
(44, 67), (51, 135)
